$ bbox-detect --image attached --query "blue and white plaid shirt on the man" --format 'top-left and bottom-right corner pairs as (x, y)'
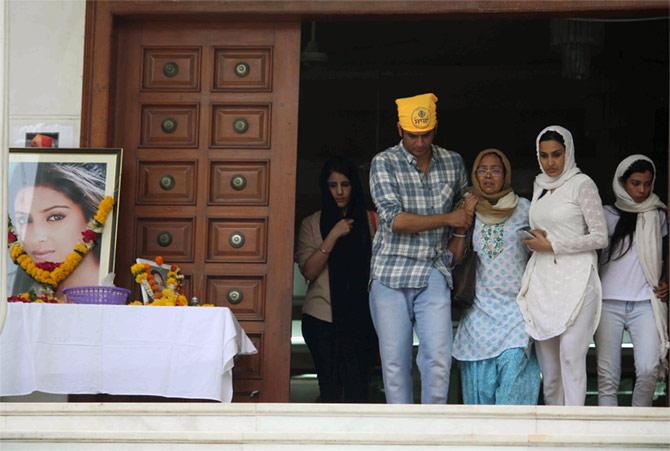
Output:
(370, 141), (468, 288)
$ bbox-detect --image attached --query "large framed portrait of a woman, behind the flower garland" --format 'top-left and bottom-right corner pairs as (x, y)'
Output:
(7, 148), (122, 295)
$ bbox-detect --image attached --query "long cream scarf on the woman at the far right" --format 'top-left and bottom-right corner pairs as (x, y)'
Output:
(612, 154), (670, 376)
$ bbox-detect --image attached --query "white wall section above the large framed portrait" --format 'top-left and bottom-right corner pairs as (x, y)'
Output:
(8, 0), (86, 147)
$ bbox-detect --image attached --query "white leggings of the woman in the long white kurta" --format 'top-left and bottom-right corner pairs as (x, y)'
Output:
(535, 289), (600, 406)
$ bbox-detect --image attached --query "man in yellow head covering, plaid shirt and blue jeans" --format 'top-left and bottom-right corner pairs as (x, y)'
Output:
(370, 93), (477, 404)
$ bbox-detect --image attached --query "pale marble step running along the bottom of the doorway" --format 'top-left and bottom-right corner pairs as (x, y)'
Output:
(0, 403), (670, 451)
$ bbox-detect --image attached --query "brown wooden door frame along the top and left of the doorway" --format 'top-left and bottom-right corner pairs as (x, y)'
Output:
(80, 0), (670, 405)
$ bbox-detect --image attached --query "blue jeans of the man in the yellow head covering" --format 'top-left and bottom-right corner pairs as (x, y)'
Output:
(370, 269), (453, 404)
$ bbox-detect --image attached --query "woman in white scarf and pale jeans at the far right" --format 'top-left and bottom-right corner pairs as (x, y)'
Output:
(596, 155), (670, 406)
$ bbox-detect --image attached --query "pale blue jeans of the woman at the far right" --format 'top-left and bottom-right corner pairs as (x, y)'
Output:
(596, 300), (660, 407)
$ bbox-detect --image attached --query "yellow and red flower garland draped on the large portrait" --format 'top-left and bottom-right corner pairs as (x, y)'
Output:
(7, 196), (114, 302)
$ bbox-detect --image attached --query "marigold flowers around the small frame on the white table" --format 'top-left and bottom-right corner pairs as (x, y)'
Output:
(130, 256), (188, 307)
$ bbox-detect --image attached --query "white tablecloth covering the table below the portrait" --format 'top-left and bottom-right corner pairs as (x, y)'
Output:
(0, 303), (256, 402)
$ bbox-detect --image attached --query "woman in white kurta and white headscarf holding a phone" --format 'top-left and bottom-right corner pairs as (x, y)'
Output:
(517, 126), (607, 405)
